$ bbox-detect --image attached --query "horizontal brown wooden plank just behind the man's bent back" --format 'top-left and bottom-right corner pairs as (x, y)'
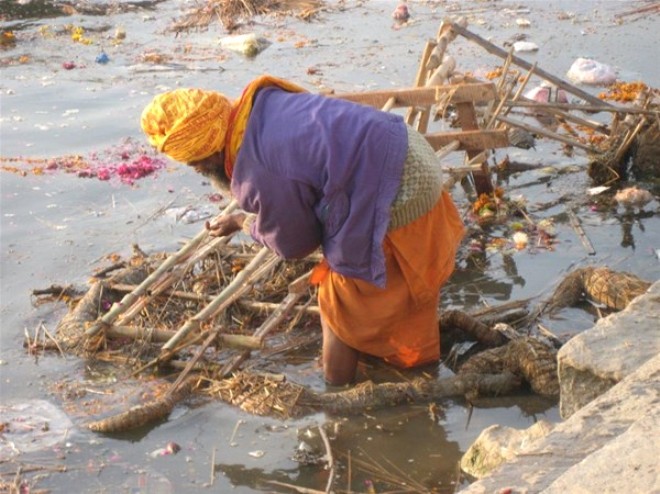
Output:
(329, 82), (495, 108)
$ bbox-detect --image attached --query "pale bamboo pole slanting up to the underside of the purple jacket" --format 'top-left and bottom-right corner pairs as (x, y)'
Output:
(161, 247), (279, 355)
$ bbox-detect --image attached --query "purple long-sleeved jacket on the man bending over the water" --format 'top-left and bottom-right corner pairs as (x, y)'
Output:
(231, 88), (408, 287)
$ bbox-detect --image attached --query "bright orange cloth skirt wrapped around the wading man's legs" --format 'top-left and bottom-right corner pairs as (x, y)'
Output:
(314, 192), (464, 367)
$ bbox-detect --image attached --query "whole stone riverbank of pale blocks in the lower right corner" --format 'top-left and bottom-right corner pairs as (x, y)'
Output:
(460, 282), (660, 494)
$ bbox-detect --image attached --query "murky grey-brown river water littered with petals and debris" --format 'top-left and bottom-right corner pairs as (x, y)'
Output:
(0, 0), (660, 493)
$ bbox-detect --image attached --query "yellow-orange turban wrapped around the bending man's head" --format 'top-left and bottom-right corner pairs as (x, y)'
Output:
(141, 89), (231, 163)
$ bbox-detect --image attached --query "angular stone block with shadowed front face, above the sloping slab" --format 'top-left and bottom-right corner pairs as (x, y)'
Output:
(557, 282), (660, 418)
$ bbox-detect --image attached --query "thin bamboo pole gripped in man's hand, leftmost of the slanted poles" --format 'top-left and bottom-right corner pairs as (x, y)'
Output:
(85, 200), (238, 337)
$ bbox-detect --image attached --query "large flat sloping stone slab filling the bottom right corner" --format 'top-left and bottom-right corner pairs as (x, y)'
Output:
(461, 354), (660, 494)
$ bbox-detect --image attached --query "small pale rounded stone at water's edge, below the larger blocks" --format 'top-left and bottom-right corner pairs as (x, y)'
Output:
(461, 420), (553, 479)
